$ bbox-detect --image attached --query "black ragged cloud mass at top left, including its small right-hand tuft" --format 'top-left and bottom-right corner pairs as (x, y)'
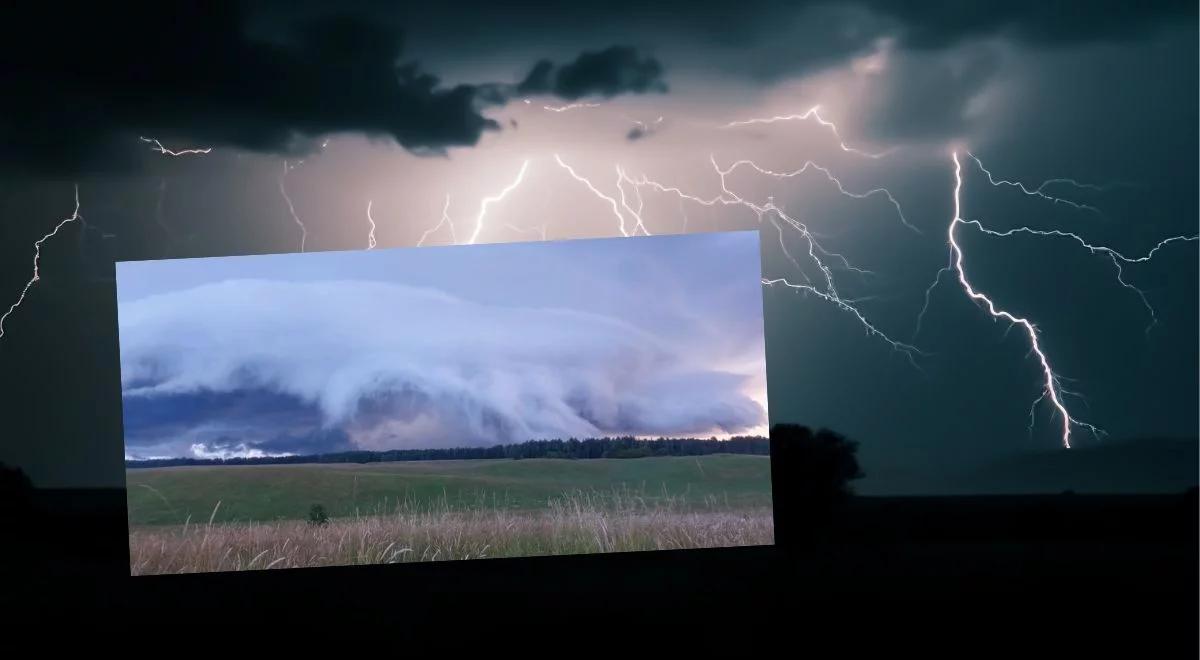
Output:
(0, 1), (664, 172)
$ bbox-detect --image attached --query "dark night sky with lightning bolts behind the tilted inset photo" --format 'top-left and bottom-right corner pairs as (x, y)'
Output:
(0, 0), (1200, 493)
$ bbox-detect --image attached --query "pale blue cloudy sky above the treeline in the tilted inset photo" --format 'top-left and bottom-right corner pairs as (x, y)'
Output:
(118, 232), (767, 457)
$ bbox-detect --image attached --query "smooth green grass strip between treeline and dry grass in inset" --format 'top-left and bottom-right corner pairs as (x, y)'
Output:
(126, 455), (770, 526)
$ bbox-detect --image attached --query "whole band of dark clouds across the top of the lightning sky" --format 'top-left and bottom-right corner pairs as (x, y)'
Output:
(0, 0), (1195, 174)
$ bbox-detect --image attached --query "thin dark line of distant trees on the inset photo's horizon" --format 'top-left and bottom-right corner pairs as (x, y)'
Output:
(125, 436), (770, 468)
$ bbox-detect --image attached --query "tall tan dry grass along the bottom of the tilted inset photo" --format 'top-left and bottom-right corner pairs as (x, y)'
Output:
(130, 491), (774, 575)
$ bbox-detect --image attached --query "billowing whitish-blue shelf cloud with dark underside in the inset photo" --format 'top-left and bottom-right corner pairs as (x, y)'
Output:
(120, 234), (766, 457)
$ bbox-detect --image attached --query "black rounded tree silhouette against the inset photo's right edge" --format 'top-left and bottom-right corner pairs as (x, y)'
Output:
(770, 424), (863, 547)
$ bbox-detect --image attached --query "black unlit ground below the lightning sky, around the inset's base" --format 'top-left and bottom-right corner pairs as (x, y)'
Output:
(0, 491), (1200, 658)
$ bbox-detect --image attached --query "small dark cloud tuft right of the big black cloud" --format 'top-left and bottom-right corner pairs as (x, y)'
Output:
(517, 46), (667, 101)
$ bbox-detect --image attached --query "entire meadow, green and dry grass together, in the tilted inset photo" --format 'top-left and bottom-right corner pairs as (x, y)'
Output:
(127, 455), (774, 575)
